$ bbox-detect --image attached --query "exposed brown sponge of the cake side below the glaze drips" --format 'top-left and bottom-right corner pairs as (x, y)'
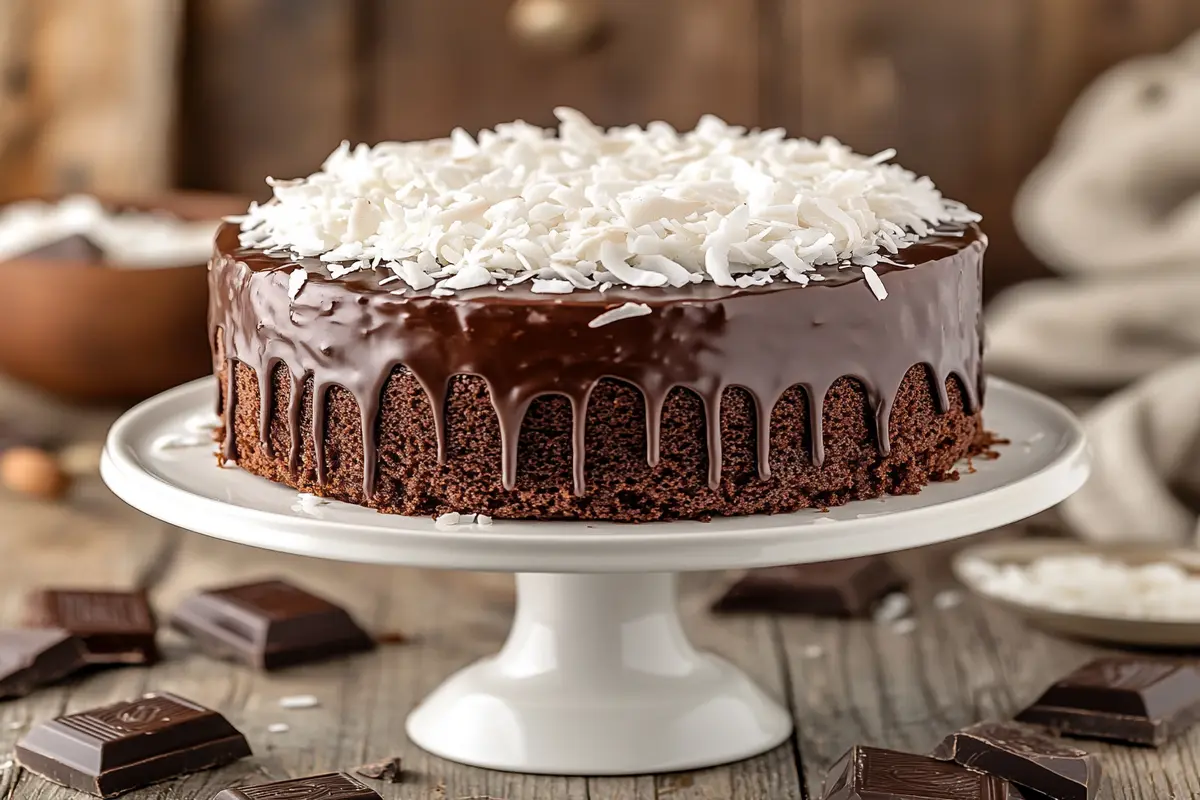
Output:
(220, 365), (980, 522)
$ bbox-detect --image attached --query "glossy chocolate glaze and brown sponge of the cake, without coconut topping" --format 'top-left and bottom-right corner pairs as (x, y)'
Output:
(210, 221), (986, 522)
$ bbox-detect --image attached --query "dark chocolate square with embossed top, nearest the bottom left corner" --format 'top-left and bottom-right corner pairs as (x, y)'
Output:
(16, 692), (251, 798)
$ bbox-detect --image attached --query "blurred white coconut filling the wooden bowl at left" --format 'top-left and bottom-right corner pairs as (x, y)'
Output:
(0, 194), (221, 269)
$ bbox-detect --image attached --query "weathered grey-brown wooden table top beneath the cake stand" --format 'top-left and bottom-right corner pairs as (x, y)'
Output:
(0, 376), (1200, 800)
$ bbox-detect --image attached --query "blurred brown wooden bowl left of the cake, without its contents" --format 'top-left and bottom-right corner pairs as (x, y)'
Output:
(0, 192), (246, 403)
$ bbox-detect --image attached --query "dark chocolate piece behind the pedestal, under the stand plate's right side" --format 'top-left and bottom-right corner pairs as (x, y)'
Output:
(713, 555), (905, 616)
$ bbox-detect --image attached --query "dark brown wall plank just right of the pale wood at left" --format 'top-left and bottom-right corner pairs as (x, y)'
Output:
(180, 0), (359, 197)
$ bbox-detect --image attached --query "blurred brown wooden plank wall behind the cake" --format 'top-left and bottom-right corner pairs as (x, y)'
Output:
(0, 0), (1200, 289)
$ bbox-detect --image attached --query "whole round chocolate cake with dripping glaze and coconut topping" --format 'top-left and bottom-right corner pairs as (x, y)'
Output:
(210, 109), (986, 522)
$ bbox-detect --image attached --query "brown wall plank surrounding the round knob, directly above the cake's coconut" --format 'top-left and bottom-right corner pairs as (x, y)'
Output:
(368, 0), (758, 139)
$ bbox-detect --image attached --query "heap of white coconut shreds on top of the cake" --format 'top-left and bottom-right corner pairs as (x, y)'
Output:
(232, 108), (979, 300)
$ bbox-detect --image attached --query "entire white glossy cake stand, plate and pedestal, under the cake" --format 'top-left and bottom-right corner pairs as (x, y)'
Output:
(102, 379), (1087, 775)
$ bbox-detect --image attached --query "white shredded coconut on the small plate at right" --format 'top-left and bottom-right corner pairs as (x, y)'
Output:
(962, 554), (1200, 622)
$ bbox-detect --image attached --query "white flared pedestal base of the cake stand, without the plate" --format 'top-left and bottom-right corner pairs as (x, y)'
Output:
(408, 572), (792, 775)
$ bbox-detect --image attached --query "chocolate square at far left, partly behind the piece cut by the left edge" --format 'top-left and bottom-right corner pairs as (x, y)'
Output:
(29, 589), (158, 664)
